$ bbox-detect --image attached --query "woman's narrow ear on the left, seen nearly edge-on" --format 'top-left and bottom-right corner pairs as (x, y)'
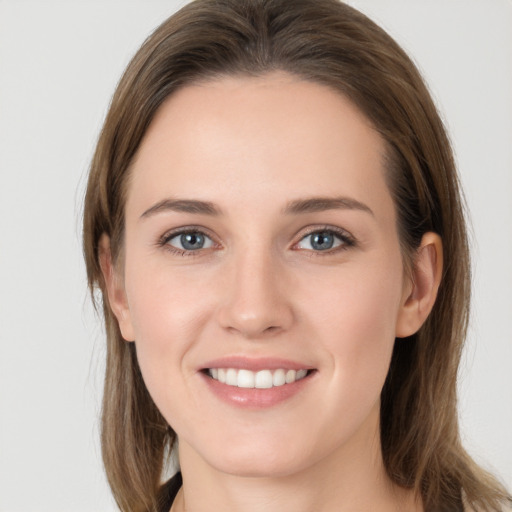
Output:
(98, 234), (135, 341)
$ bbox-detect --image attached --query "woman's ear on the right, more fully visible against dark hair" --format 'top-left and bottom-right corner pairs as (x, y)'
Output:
(395, 232), (443, 338)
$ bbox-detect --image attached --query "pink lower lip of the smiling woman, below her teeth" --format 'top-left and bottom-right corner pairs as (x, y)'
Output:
(201, 372), (316, 409)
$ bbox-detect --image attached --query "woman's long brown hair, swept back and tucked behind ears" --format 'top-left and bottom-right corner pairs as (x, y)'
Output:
(84, 0), (510, 512)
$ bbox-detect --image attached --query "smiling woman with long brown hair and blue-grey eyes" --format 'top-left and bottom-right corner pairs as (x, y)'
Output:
(84, 0), (510, 512)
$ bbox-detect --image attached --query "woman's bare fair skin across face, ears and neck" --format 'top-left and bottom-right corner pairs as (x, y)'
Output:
(100, 73), (442, 512)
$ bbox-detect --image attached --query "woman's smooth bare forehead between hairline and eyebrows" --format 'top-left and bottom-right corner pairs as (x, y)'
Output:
(128, 73), (389, 222)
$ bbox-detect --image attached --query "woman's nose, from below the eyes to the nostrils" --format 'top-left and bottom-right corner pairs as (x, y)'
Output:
(218, 250), (293, 339)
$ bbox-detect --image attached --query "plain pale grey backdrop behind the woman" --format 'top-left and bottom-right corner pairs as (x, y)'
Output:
(0, 0), (512, 512)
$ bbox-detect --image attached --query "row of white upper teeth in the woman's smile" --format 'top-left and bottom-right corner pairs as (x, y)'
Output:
(208, 368), (308, 389)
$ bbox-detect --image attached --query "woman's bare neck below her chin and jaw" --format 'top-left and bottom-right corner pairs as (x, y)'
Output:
(172, 406), (423, 512)
